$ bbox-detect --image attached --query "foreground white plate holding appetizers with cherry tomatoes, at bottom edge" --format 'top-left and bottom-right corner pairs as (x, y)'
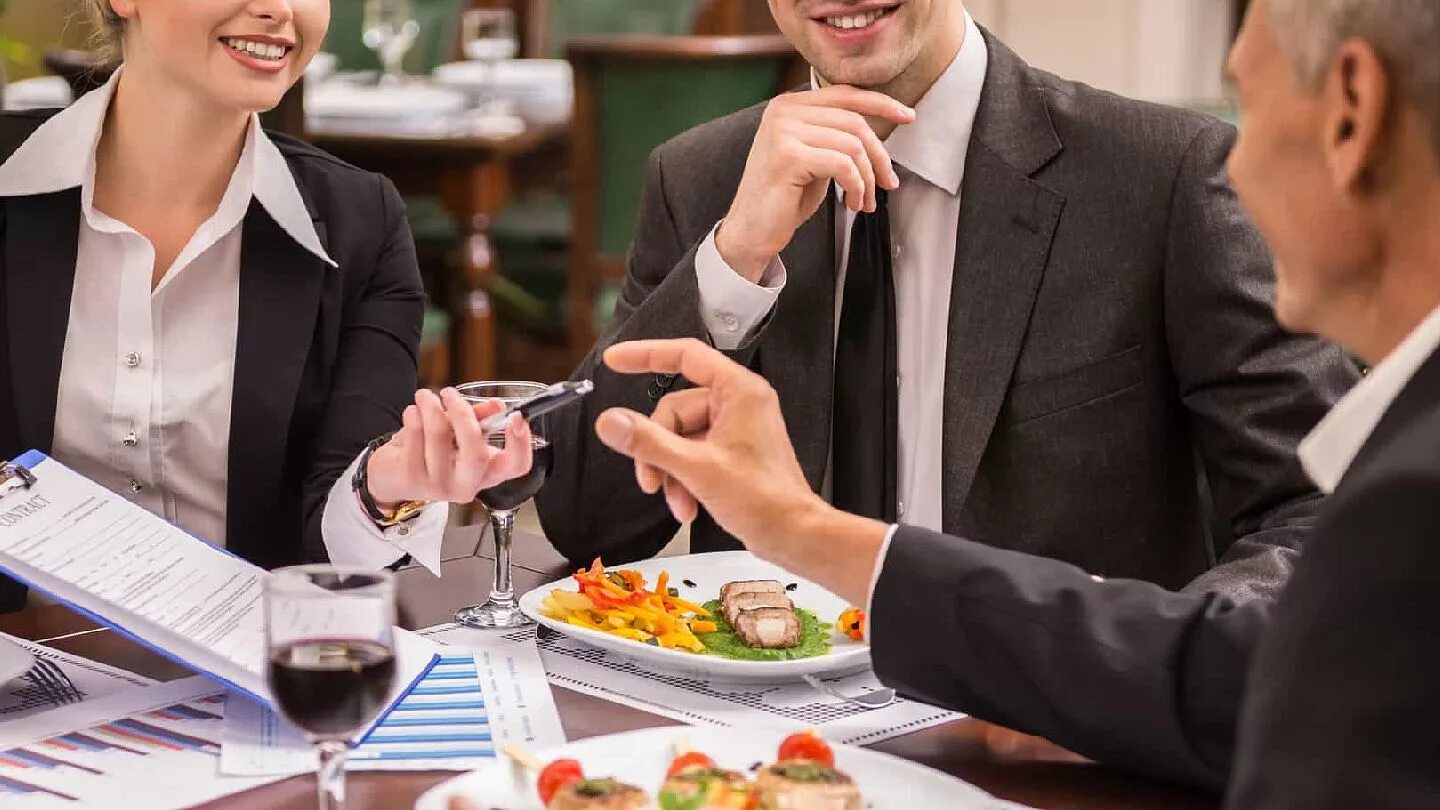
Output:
(415, 726), (1012, 810)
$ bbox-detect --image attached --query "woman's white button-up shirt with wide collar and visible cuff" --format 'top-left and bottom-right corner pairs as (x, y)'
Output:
(0, 71), (448, 569)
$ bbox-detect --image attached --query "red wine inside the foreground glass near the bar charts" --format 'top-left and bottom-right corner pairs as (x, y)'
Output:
(268, 638), (395, 738)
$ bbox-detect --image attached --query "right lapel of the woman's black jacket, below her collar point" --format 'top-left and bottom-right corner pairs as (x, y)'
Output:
(226, 200), (328, 561)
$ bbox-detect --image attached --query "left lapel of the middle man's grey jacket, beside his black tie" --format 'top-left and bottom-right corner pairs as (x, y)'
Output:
(759, 193), (835, 491)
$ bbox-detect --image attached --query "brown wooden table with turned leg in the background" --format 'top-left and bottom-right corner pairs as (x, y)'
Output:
(305, 124), (569, 382)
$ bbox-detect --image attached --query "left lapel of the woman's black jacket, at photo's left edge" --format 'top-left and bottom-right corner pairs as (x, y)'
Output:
(0, 189), (81, 453)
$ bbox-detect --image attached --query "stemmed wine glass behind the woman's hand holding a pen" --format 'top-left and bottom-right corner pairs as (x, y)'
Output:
(455, 382), (552, 628)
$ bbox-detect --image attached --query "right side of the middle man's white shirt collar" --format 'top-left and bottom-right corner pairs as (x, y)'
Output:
(811, 12), (989, 195)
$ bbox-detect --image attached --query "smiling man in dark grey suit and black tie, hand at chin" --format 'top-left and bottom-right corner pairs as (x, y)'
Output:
(539, 0), (1356, 597)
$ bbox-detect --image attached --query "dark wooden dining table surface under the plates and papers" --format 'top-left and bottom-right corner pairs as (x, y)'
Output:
(0, 528), (1218, 810)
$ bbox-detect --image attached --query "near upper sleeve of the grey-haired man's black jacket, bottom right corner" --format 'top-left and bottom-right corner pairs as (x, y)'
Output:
(1227, 464), (1440, 810)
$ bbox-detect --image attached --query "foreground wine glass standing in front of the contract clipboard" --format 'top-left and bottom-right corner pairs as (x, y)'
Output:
(265, 565), (395, 810)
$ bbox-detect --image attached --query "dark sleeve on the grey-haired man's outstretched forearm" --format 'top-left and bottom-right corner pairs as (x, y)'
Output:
(870, 526), (1272, 790)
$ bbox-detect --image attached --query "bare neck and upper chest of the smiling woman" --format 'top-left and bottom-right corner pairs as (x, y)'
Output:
(95, 65), (249, 220)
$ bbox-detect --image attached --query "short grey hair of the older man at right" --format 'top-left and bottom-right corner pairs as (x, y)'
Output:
(1270, 0), (1440, 153)
